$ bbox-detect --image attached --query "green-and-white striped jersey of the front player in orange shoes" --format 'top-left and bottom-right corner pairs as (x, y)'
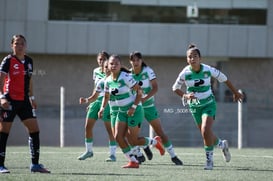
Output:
(104, 71), (137, 110)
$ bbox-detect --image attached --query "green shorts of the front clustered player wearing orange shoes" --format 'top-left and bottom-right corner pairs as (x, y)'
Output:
(115, 105), (144, 127)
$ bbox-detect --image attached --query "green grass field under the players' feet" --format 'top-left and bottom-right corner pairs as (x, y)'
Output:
(0, 147), (273, 181)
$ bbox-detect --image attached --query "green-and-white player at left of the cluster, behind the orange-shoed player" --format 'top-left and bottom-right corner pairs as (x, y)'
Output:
(78, 52), (117, 162)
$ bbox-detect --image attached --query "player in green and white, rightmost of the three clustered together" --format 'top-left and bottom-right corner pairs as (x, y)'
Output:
(129, 51), (183, 165)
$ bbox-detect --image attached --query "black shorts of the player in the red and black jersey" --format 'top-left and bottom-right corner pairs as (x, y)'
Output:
(2, 99), (36, 122)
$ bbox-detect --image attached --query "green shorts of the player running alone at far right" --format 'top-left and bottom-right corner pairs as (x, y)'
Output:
(190, 100), (216, 125)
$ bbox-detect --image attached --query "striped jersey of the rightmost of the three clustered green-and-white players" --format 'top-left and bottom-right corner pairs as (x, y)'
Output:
(132, 66), (156, 108)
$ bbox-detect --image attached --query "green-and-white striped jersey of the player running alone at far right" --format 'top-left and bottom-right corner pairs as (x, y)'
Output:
(172, 64), (227, 100)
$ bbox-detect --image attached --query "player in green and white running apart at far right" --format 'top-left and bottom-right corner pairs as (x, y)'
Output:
(172, 44), (243, 170)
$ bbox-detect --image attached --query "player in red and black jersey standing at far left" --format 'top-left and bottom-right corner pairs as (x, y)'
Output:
(0, 35), (50, 173)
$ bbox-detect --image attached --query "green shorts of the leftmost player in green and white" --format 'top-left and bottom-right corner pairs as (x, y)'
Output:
(86, 99), (110, 122)
